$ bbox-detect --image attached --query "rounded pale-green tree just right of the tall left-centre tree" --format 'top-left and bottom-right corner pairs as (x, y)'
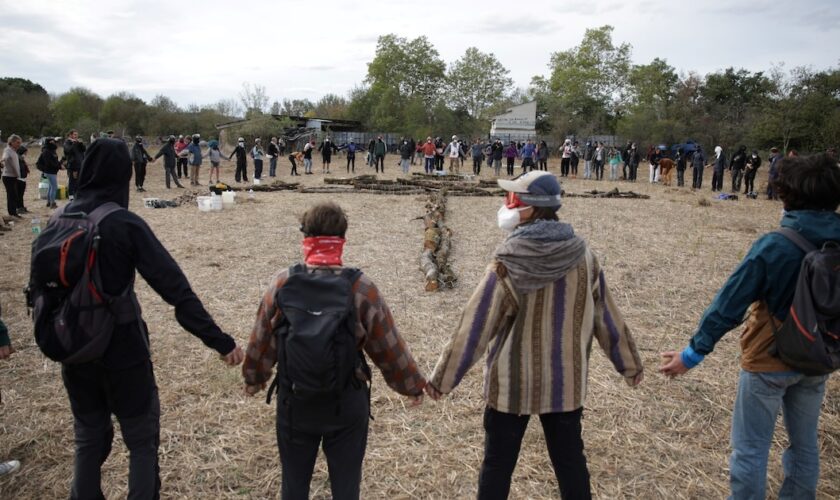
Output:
(446, 47), (513, 119)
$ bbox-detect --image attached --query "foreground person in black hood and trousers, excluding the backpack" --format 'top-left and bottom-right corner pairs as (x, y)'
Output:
(55, 138), (243, 499)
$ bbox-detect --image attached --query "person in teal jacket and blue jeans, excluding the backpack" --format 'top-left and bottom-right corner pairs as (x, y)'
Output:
(659, 154), (840, 500)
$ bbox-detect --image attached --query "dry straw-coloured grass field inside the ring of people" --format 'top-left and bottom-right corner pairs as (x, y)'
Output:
(0, 148), (840, 499)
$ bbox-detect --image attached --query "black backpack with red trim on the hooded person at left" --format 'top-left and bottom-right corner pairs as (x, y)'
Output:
(26, 202), (146, 364)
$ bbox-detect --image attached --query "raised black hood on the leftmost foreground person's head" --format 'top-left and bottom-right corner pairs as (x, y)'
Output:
(66, 139), (131, 213)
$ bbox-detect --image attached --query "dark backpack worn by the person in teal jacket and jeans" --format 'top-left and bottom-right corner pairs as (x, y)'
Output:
(771, 228), (840, 375)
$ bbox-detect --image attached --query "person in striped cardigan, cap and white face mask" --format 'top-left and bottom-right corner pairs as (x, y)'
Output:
(426, 171), (643, 498)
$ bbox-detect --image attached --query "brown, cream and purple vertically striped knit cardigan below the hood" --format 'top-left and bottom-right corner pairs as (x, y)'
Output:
(431, 249), (643, 415)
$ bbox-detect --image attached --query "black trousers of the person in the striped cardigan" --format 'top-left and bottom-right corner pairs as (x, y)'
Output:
(478, 407), (592, 500)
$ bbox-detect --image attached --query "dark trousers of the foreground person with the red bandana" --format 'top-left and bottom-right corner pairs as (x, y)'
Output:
(277, 389), (370, 500)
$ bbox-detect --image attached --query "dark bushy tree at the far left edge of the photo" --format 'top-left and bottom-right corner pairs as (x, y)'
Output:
(0, 78), (51, 137)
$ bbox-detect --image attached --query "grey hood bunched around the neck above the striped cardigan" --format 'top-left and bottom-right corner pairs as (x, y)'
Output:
(495, 220), (586, 293)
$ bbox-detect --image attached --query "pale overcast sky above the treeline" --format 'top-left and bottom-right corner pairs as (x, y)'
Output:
(0, 0), (840, 109)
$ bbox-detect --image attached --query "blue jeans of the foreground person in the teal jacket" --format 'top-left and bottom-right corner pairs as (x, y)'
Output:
(729, 370), (828, 500)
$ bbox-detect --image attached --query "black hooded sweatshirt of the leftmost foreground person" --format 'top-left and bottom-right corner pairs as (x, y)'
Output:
(65, 139), (236, 369)
